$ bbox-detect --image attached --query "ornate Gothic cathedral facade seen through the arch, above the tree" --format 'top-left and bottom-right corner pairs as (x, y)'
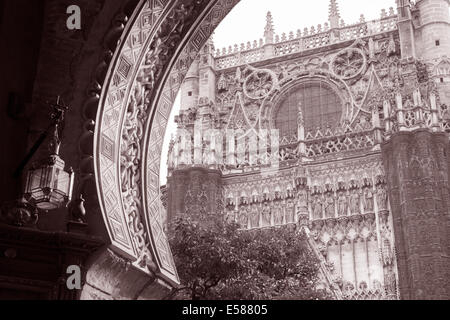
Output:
(166, 0), (450, 299)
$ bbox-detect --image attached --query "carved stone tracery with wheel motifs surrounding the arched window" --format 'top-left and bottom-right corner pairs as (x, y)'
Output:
(209, 38), (414, 161)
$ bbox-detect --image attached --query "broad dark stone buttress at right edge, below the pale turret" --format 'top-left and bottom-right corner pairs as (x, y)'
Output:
(382, 129), (450, 299)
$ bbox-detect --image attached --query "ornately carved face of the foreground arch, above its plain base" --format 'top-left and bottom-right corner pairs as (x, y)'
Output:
(94, 0), (238, 283)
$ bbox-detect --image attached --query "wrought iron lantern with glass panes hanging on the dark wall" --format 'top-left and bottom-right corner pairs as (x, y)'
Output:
(24, 98), (75, 211)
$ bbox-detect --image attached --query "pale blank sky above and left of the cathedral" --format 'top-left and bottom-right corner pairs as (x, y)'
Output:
(161, 0), (397, 185)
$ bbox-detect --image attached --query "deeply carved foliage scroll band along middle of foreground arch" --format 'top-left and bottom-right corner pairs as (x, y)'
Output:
(120, 2), (212, 276)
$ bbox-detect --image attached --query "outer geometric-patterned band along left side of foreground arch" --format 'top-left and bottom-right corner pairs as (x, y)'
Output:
(94, 1), (176, 281)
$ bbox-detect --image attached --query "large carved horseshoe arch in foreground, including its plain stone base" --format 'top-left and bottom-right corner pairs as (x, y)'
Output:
(75, 0), (239, 299)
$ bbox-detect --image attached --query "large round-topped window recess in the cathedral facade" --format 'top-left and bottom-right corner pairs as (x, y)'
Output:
(275, 82), (342, 139)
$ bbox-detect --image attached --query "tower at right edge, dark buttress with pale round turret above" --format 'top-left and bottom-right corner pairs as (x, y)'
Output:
(382, 0), (450, 300)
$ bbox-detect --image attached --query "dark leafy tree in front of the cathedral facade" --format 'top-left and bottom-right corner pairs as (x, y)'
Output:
(168, 218), (329, 300)
